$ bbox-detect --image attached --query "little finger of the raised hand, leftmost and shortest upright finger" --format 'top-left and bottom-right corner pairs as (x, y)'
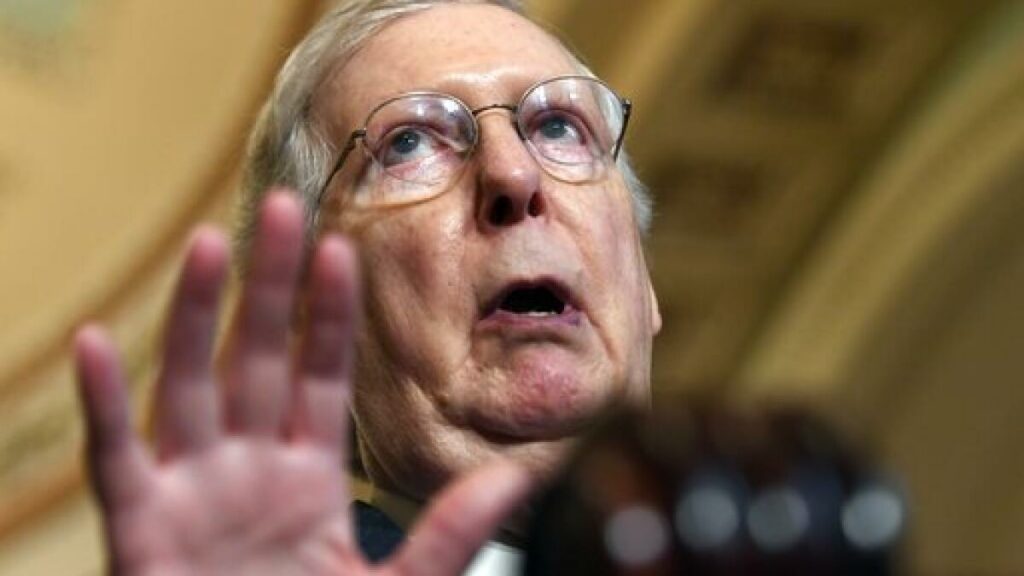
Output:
(75, 326), (152, 509)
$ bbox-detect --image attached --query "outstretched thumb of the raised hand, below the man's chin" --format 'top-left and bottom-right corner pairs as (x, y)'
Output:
(386, 461), (532, 576)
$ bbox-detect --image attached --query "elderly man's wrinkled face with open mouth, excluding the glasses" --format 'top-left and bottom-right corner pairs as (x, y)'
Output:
(316, 5), (660, 497)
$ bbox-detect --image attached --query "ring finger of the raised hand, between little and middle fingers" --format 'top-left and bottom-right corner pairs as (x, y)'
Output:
(156, 228), (227, 458)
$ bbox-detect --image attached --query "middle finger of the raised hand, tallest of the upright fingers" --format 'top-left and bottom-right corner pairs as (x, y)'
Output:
(225, 192), (303, 436)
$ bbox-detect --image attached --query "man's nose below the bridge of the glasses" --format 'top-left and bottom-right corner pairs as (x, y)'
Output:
(476, 110), (548, 230)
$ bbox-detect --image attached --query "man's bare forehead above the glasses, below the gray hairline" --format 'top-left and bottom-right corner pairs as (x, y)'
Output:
(317, 4), (579, 137)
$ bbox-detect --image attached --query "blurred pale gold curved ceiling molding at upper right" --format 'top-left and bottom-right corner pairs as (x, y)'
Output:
(733, 3), (1024, 398)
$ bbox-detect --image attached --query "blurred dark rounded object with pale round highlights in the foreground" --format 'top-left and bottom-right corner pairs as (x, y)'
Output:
(525, 401), (907, 576)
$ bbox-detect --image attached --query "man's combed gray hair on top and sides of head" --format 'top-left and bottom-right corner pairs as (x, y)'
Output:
(236, 0), (651, 258)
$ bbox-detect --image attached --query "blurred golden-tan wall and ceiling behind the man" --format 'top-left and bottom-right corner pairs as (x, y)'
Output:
(0, 0), (1024, 576)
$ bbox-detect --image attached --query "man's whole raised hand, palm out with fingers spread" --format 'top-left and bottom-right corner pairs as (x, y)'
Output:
(75, 193), (530, 576)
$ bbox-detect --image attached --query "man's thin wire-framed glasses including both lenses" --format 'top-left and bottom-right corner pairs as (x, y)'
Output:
(318, 76), (632, 208)
